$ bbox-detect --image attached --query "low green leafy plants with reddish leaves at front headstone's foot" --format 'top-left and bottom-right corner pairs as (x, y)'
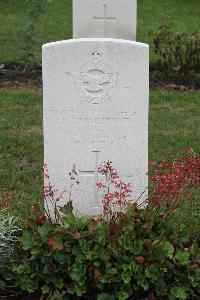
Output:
(12, 205), (200, 299)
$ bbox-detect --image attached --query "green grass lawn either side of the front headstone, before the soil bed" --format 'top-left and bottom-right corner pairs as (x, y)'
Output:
(0, 91), (200, 232)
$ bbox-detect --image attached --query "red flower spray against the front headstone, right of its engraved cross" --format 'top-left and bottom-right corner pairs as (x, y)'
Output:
(97, 161), (133, 216)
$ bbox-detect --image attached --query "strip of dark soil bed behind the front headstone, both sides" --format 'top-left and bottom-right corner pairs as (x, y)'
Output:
(0, 65), (200, 91)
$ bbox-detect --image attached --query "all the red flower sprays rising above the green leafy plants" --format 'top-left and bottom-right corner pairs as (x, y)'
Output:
(30, 150), (200, 224)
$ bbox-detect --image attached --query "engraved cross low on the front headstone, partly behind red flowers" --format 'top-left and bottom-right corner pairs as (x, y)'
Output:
(79, 151), (100, 207)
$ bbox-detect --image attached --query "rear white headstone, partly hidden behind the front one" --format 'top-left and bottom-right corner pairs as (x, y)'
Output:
(73, 0), (137, 40)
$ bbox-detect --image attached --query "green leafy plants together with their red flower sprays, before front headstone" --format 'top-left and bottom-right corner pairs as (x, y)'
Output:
(11, 153), (200, 300)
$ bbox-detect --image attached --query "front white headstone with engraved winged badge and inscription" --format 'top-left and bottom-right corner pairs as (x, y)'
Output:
(43, 39), (149, 215)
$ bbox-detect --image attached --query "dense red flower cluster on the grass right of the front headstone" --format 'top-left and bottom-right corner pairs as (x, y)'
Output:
(149, 152), (200, 205)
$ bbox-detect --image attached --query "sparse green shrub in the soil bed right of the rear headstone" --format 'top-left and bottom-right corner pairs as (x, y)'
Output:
(153, 25), (200, 87)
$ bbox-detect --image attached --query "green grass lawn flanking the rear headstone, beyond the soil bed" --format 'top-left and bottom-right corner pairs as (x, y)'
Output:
(0, 0), (200, 64)
